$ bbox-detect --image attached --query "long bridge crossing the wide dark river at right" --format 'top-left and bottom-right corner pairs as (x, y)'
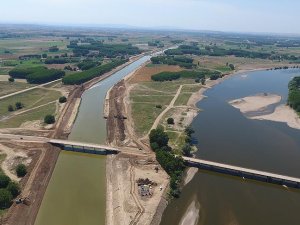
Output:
(183, 157), (300, 188)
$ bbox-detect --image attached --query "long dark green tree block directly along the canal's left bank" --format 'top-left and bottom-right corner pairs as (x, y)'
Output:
(63, 60), (127, 85)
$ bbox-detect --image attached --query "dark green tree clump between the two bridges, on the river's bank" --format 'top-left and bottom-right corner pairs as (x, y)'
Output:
(149, 127), (185, 198)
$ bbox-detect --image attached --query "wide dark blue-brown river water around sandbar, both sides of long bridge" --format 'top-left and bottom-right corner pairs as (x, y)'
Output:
(161, 69), (300, 225)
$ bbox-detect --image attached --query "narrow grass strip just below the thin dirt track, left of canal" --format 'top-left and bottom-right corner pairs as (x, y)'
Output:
(0, 103), (56, 128)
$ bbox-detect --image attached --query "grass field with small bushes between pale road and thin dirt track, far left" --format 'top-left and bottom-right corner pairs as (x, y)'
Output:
(0, 88), (61, 116)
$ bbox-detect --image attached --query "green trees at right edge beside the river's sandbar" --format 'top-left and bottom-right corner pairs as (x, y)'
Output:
(288, 77), (300, 114)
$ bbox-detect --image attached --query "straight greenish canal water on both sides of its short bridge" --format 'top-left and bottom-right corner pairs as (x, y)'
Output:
(35, 56), (150, 225)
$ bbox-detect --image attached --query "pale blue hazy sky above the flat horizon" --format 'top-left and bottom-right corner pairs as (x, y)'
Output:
(0, 0), (300, 34)
